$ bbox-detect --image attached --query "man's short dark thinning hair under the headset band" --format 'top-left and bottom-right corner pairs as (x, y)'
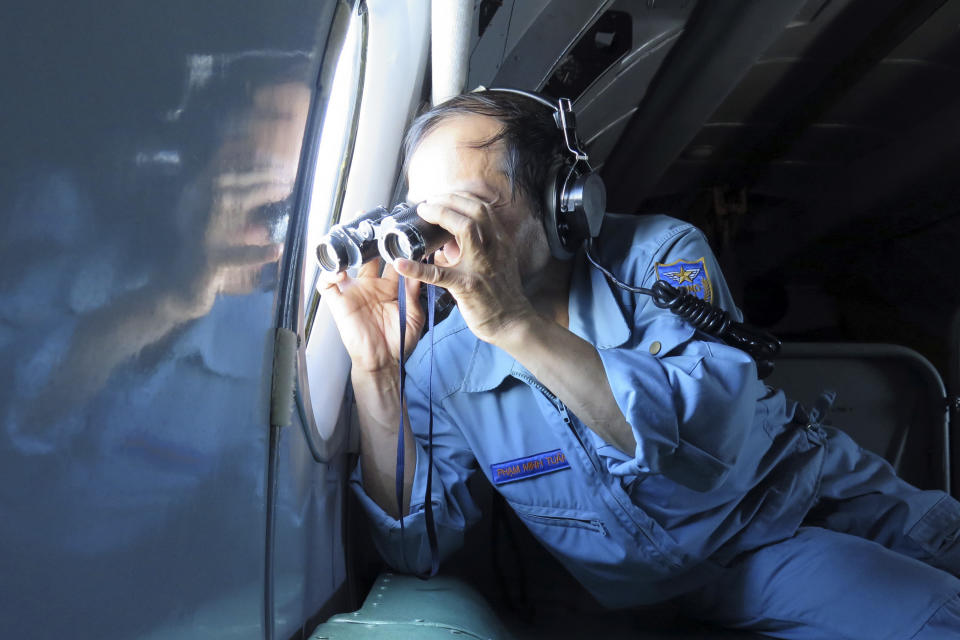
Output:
(403, 90), (569, 216)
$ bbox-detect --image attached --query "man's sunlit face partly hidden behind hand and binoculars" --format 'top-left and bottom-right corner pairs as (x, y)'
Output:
(407, 115), (550, 281)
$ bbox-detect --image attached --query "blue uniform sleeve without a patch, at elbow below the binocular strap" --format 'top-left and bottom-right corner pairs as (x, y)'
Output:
(351, 376), (480, 573)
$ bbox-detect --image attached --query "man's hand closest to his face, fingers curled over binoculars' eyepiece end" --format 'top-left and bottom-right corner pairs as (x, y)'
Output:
(394, 193), (536, 342)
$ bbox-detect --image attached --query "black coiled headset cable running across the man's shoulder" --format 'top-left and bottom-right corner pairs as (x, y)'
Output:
(586, 238), (781, 379)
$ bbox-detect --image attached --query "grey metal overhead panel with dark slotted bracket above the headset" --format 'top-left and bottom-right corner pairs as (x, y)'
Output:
(468, 0), (697, 174)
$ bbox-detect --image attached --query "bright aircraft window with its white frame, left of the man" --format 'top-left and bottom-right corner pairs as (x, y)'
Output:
(296, 0), (430, 461)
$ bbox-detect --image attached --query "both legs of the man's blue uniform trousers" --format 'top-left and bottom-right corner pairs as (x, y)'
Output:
(690, 428), (960, 640)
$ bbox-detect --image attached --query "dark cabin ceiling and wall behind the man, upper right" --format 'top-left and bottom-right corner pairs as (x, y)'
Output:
(477, 0), (960, 376)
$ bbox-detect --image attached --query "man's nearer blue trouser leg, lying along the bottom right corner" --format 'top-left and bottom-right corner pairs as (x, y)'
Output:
(681, 527), (960, 640)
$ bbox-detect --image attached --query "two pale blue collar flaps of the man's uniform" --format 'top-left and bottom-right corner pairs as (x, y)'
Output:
(463, 252), (630, 392)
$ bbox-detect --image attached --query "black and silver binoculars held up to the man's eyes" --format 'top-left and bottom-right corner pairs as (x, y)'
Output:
(317, 204), (451, 273)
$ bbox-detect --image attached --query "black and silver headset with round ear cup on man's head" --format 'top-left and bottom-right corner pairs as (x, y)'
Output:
(474, 86), (607, 260)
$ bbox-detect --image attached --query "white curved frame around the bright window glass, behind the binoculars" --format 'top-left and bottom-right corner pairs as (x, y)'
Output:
(295, 0), (430, 462)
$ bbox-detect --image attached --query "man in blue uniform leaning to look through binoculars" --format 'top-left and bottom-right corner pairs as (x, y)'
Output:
(326, 91), (960, 639)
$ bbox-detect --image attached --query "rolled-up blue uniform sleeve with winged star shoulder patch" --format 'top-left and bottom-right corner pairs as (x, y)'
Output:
(599, 222), (764, 491)
